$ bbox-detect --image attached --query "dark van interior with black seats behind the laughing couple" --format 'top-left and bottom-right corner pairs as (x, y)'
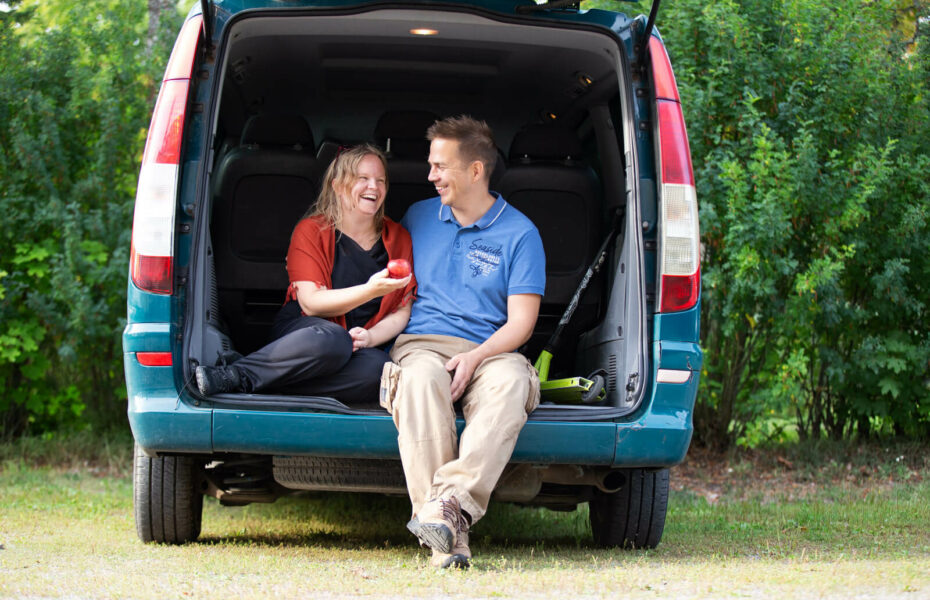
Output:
(210, 11), (625, 386)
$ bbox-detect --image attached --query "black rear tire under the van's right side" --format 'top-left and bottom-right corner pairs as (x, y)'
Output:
(588, 469), (668, 548)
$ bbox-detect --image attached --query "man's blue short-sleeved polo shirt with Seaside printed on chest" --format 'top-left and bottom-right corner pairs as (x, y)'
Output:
(401, 194), (546, 344)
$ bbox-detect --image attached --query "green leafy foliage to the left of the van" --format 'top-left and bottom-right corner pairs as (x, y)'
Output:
(0, 0), (179, 433)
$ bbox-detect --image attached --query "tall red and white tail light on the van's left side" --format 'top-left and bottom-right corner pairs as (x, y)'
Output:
(129, 15), (203, 294)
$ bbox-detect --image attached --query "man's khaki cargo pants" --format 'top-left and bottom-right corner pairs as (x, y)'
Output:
(381, 335), (539, 522)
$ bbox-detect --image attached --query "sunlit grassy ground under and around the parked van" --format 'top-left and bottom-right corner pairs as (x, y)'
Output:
(0, 439), (930, 598)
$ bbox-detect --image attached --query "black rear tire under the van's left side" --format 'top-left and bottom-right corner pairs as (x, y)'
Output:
(132, 444), (203, 544)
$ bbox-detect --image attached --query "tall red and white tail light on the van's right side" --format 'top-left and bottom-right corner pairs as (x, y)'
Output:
(649, 36), (701, 312)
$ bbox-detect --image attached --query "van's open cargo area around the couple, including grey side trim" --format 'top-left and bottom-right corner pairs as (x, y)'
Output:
(183, 5), (651, 420)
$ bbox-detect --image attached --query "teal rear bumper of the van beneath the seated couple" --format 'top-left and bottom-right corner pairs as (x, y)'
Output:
(126, 368), (697, 467)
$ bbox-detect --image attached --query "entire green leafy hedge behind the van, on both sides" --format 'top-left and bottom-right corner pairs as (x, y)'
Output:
(0, 0), (930, 446)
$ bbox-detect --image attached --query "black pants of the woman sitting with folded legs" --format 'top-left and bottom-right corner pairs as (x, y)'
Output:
(233, 301), (391, 404)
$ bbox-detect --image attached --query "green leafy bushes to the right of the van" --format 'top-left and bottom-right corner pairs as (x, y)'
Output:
(592, 0), (930, 446)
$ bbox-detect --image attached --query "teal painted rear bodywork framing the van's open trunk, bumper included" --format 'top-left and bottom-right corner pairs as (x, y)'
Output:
(123, 0), (702, 478)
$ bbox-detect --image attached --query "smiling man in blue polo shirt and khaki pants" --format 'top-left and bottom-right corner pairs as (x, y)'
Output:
(381, 116), (546, 567)
